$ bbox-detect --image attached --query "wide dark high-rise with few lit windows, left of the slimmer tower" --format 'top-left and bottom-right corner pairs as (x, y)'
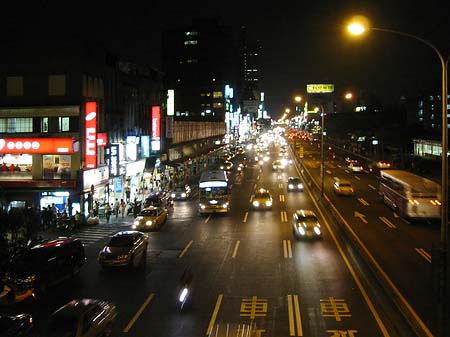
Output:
(163, 18), (239, 121)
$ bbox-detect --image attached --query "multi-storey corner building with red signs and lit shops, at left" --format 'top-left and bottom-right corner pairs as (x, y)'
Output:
(0, 40), (162, 214)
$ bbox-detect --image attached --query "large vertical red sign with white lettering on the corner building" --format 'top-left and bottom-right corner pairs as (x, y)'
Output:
(84, 102), (97, 169)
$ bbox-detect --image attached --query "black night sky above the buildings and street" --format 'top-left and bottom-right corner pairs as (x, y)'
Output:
(0, 0), (450, 115)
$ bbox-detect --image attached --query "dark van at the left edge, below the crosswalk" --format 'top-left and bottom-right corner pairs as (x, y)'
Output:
(6, 237), (86, 294)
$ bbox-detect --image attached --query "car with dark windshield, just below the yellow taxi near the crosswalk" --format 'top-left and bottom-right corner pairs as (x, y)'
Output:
(97, 231), (148, 268)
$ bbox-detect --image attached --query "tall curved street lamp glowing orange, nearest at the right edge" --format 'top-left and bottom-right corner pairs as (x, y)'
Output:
(347, 16), (450, 336)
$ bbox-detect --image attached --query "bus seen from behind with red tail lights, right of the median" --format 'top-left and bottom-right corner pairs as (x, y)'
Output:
(380, 170), (441, 219)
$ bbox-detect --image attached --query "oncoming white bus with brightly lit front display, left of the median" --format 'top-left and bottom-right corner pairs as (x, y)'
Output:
(198, 170), (231, 214)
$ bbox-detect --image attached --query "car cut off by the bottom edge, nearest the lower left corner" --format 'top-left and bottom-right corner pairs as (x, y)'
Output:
(46, 298), (117, 337)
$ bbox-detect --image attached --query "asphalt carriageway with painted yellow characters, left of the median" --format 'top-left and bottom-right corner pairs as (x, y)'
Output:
(3, 140), (431, 337)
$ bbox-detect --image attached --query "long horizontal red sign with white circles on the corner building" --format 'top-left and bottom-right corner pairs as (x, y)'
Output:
(0, 138), (73, 154)
